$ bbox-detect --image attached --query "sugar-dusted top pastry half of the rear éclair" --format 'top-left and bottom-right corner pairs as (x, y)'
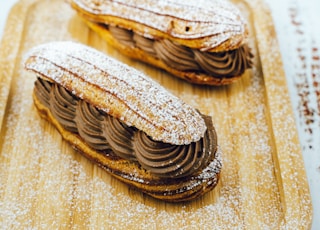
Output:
(72, 0), (248, 51)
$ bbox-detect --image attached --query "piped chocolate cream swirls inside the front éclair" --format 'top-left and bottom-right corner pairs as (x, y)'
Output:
(34, 78), (217, 178)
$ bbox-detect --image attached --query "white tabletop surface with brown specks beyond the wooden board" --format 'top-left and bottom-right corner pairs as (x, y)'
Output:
(0, 0), (320, 230)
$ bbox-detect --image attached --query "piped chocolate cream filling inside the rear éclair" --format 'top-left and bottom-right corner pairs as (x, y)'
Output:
(109, 25), (253, 78)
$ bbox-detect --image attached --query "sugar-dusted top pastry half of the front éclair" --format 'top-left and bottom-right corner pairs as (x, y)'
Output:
(25, 41), (206, 145)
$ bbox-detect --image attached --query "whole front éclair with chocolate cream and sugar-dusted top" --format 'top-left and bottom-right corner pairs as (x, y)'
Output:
(25, 42), (221, 202)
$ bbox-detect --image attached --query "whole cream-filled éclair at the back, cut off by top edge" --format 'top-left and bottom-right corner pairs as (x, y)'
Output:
(71, 0), (253, 85)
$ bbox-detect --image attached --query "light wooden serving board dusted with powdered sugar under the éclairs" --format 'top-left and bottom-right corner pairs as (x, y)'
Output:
(0, 0), (312, 229)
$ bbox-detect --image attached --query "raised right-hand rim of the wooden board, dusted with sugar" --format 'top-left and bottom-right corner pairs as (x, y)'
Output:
(245, 0), (312, 229)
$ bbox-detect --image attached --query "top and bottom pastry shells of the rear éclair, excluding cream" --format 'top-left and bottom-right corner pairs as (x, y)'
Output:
(70, 0), (248, 86)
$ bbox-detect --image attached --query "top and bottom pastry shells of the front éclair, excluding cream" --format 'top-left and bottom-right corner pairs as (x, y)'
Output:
(25, 42), (221, 202)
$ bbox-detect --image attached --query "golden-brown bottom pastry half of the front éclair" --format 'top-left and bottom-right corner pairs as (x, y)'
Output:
(33, 90), (221, 202)
